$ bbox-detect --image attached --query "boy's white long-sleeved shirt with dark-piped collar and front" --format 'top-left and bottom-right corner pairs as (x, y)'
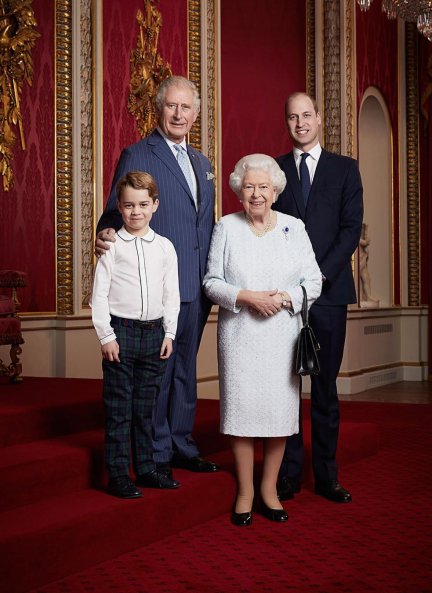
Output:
(91, 226), (180, 344)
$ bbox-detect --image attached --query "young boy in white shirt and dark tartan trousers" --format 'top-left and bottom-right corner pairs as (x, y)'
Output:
(91, 172), (180, 498)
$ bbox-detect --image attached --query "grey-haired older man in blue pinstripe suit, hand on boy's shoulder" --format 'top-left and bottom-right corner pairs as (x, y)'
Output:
(96, 76), (218, 476)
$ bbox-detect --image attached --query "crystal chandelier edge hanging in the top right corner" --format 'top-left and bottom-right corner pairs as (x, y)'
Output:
(357, 0), (432, 41)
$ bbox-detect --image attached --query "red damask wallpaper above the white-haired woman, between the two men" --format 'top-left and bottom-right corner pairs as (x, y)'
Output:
(221, 0), (306, 214)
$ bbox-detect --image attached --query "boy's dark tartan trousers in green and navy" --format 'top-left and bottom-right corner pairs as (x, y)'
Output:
(102, 318), (166, 478)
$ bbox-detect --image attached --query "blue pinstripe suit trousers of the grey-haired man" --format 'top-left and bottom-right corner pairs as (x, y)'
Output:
(153, 292), (211, 463)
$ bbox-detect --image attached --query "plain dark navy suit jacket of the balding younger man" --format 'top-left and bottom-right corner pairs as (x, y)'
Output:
(274, 149), (363, 305)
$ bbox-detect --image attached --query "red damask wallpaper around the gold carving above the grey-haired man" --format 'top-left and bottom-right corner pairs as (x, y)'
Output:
(103, 0), (188, 202)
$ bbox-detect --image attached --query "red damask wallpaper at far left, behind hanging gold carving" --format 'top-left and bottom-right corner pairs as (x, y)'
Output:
(0, 0), (56, 312)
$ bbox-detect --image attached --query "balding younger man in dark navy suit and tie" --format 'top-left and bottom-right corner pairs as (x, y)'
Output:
(274, 93), (363, 502)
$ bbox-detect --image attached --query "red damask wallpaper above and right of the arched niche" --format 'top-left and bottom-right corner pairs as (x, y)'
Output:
(356, 2), (400, 305)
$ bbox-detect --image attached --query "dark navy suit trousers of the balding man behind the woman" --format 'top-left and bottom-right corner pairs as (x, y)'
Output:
(280, 304), (347, 481)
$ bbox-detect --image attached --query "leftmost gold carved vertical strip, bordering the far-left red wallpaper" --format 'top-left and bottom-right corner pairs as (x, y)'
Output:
(55, 0), (73, 315)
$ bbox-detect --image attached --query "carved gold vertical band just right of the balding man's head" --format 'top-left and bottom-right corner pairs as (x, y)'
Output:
(323, 0), (341, 154)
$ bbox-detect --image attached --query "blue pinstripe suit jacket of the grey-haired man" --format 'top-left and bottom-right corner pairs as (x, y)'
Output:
(97, 131), (215, 302)
